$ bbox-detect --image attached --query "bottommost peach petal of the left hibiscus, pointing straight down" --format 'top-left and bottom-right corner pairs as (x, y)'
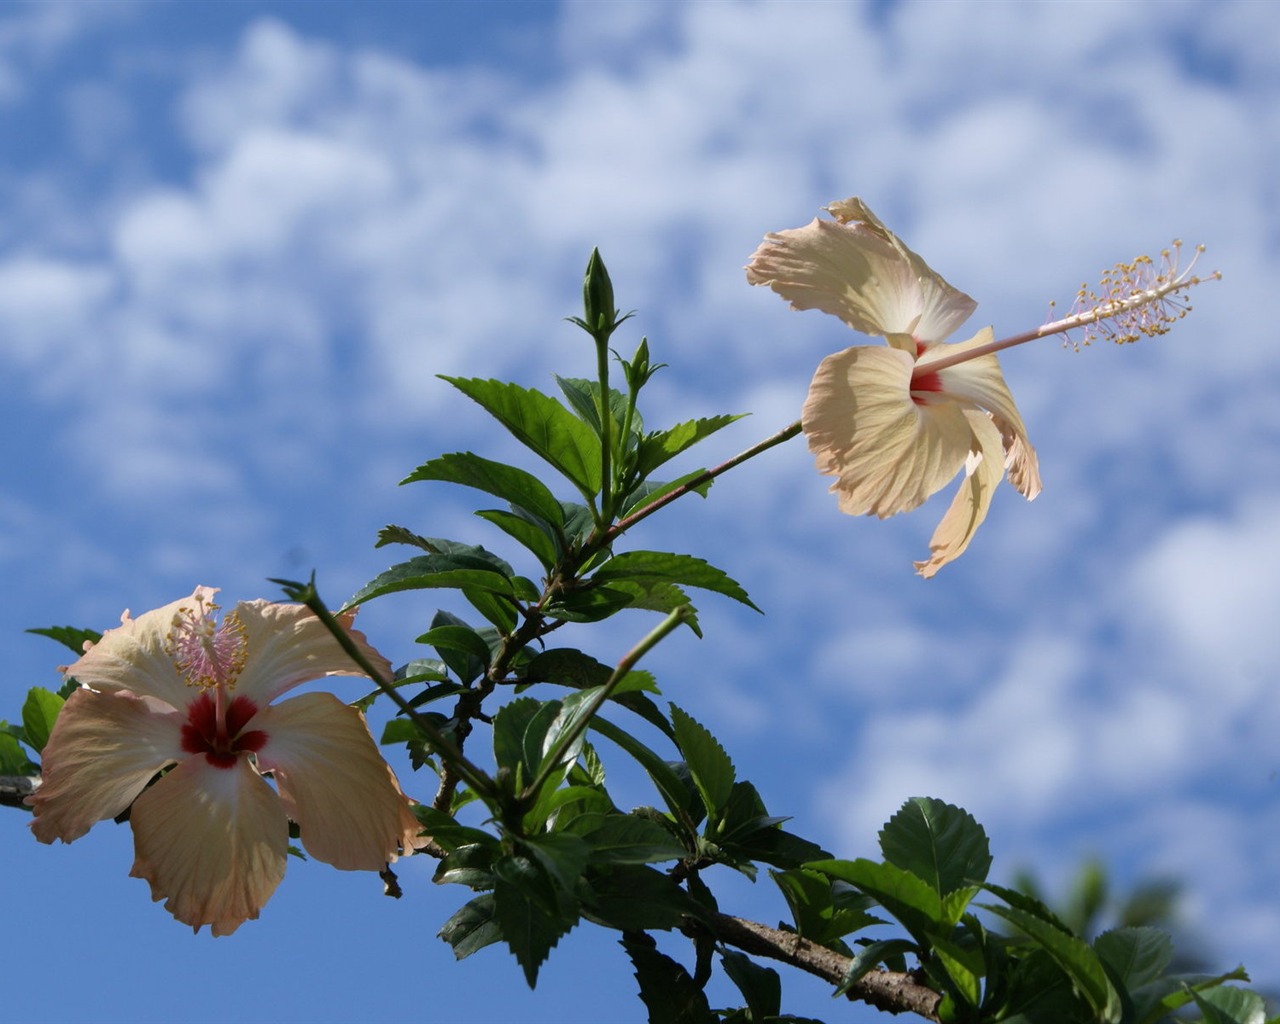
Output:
(129, 756), (289, 936)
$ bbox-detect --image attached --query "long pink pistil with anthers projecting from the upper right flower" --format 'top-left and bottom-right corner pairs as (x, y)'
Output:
(913, 239), (1222, 378)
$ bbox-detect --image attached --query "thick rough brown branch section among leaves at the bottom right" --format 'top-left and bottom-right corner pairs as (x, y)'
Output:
(712, 914), (942, 1021)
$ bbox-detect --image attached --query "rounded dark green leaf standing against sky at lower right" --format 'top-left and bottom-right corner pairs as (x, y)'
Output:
(879, 796), (991, 896)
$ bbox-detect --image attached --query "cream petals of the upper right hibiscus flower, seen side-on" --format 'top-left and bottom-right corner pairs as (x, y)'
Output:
(746, 198), (1041, 576)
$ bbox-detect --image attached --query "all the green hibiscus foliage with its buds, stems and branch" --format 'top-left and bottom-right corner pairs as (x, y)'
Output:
(0, 252), (1265, 1024)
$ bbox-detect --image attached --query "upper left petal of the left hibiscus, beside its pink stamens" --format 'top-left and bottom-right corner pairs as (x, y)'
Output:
(64, 586), (218, 708)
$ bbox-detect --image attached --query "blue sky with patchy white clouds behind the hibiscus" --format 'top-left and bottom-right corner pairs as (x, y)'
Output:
(0, 0), (1280, 1021)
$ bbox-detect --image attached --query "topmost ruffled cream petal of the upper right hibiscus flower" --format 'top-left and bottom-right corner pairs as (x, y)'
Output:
(746, 198), (977, 340)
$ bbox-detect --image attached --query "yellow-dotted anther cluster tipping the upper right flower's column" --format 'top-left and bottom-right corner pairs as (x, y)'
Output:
(1059, 239), (1222, 351)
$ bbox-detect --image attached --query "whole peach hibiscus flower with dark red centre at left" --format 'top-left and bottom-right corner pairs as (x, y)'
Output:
(28, 586), (421, 936)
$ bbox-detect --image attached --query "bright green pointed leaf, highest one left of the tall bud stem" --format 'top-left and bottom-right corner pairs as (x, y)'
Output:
(442, 376), (600, 498)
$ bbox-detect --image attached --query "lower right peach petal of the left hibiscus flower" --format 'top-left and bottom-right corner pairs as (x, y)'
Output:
(253, 694), (421, 872)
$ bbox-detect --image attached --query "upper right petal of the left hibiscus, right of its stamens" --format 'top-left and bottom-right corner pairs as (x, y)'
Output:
(236, 600), (392, 705)
